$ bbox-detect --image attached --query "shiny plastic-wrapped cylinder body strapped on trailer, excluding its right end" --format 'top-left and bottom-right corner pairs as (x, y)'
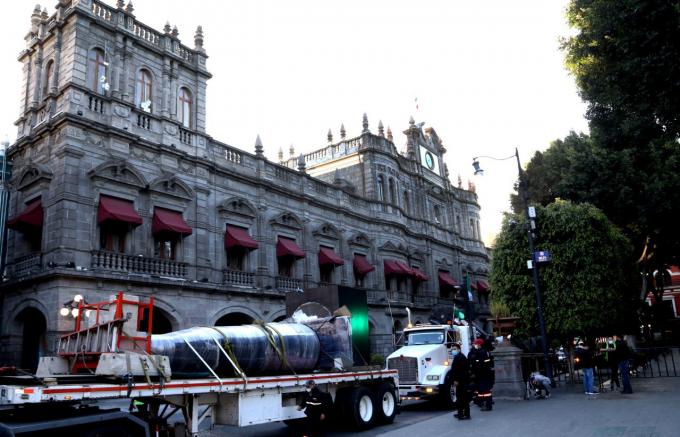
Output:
(151, 323), (320, 377)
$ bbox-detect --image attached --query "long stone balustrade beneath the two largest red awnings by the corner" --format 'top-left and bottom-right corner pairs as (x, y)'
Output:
(91, 250), (187, 278)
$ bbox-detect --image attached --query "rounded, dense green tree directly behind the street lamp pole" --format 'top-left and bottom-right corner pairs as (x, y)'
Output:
(490, 200), (637, 339)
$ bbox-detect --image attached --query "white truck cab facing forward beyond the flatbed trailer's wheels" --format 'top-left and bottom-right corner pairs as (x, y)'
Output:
(387, 325), (473, 408)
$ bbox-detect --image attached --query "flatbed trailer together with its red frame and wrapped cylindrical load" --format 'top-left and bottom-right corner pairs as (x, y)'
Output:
(0, 293), (400, 437)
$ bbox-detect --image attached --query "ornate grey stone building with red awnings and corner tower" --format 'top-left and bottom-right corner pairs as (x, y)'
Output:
(0, 0), (488, 367)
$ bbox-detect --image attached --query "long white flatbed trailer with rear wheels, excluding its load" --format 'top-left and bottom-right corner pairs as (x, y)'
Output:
(0, 368), (400, 436)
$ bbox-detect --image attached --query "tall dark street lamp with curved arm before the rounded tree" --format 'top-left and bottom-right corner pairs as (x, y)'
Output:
(472, 147), (552, 381)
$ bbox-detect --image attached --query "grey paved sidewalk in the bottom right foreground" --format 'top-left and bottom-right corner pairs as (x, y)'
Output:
(380, 377), (680, 437)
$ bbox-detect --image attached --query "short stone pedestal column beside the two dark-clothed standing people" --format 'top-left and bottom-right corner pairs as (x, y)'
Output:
(493, 341), (526, 400)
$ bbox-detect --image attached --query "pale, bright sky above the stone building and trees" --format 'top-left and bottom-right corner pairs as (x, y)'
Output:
(0, 0), (587, 245)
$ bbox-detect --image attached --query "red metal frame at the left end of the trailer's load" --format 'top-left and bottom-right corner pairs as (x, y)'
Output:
(59, 291), (154, 373)
